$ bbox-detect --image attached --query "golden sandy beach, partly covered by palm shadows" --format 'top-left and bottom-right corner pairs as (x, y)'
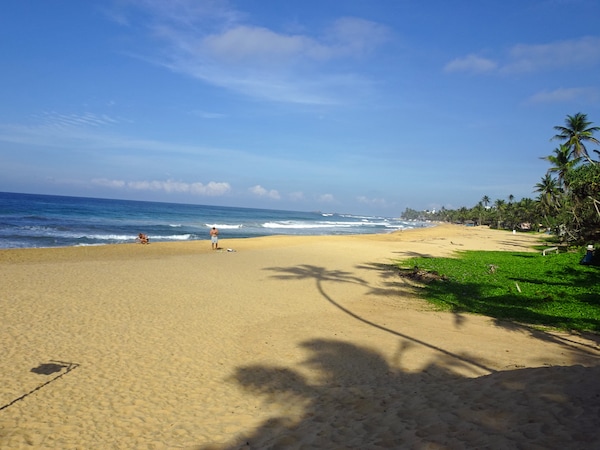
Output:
(0, 225), (600, 449)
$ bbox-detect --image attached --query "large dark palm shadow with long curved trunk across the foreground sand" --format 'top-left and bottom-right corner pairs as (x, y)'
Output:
(198, 266), (600, 450)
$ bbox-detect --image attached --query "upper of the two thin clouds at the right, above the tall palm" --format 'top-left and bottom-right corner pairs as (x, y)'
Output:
(444, 36), (600, 74)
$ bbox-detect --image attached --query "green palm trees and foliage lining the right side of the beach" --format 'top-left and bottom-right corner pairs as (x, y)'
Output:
(402, 113), (600, 244)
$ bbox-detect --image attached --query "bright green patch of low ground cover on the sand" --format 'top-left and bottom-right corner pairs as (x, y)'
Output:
(398, 251), (600, 332)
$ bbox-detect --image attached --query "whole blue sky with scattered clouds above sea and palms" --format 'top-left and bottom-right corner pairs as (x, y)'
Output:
(0, 0), (600, 216)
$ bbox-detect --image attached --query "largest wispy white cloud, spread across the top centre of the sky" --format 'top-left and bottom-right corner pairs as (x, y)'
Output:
(114, 0), (390, 104)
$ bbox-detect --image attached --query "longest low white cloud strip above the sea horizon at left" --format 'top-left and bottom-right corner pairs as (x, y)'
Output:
(92, 178), (231, 197)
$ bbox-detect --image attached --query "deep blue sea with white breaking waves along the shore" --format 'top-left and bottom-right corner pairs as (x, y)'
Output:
(0, 192), (429, 248)
